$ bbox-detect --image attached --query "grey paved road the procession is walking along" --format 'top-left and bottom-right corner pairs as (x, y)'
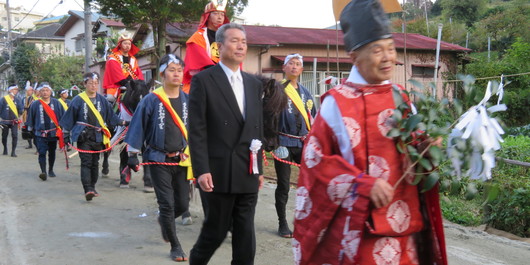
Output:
(0, 143), (530, 265)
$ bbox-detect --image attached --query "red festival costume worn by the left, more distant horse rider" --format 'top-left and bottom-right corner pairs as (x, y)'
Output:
(103, 35), (144, 97)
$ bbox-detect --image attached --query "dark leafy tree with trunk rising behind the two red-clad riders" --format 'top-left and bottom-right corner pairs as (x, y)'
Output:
(93, 0), (248, 64)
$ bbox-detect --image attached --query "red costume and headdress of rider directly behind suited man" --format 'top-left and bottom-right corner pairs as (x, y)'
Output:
(182, 1), (230, 94)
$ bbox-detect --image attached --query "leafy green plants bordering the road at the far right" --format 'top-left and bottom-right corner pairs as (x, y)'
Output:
(441, 134), (530, 237)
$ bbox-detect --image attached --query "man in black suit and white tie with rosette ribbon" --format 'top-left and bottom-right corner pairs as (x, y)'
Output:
(189, 23), (263, 265)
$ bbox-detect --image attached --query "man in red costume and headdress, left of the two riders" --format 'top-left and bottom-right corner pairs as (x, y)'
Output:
(103, 34), (144, 103)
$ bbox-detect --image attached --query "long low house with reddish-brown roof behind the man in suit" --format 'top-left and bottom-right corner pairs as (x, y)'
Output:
(121, 23), (471, 96)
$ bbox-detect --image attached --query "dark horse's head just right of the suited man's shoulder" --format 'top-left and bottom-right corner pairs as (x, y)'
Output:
(256, 75), (287, 151)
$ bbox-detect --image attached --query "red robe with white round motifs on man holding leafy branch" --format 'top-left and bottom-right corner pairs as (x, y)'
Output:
(293, 71), (447, 265)
